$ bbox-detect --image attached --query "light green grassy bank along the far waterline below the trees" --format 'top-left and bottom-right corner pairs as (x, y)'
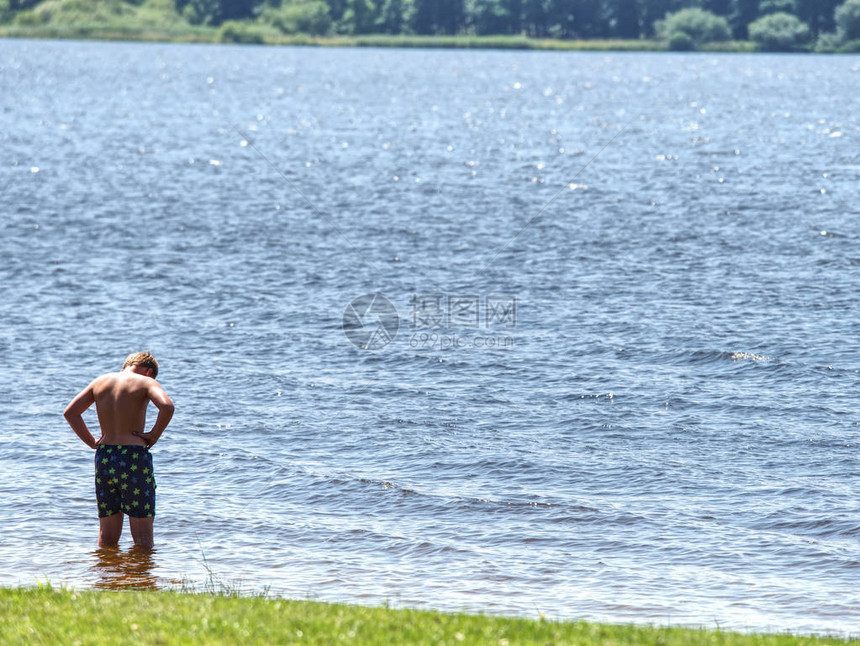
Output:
(0, 23), (755, 52)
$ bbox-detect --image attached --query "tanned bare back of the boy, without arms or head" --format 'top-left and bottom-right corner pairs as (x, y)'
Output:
(92, 371), (155, 446)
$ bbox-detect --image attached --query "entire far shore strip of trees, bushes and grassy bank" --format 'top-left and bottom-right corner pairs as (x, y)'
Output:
(0, 0), (860, 52)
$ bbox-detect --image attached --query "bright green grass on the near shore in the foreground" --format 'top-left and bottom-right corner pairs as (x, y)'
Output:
(0, 586), (845, 646)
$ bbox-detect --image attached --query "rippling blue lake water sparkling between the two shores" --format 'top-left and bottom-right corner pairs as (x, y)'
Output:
(0, 41), (860, 634)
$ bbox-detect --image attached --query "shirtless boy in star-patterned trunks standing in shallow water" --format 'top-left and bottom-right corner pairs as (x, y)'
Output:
(63, 352), (173, 548)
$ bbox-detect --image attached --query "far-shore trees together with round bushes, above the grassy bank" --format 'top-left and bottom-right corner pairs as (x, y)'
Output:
(6, 0), (860, 46)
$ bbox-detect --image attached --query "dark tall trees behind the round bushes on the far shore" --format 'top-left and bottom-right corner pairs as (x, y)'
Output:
(176, 0), (840, 39)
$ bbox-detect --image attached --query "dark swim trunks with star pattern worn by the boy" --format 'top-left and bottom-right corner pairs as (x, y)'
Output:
(96, 444), (155, 518)
